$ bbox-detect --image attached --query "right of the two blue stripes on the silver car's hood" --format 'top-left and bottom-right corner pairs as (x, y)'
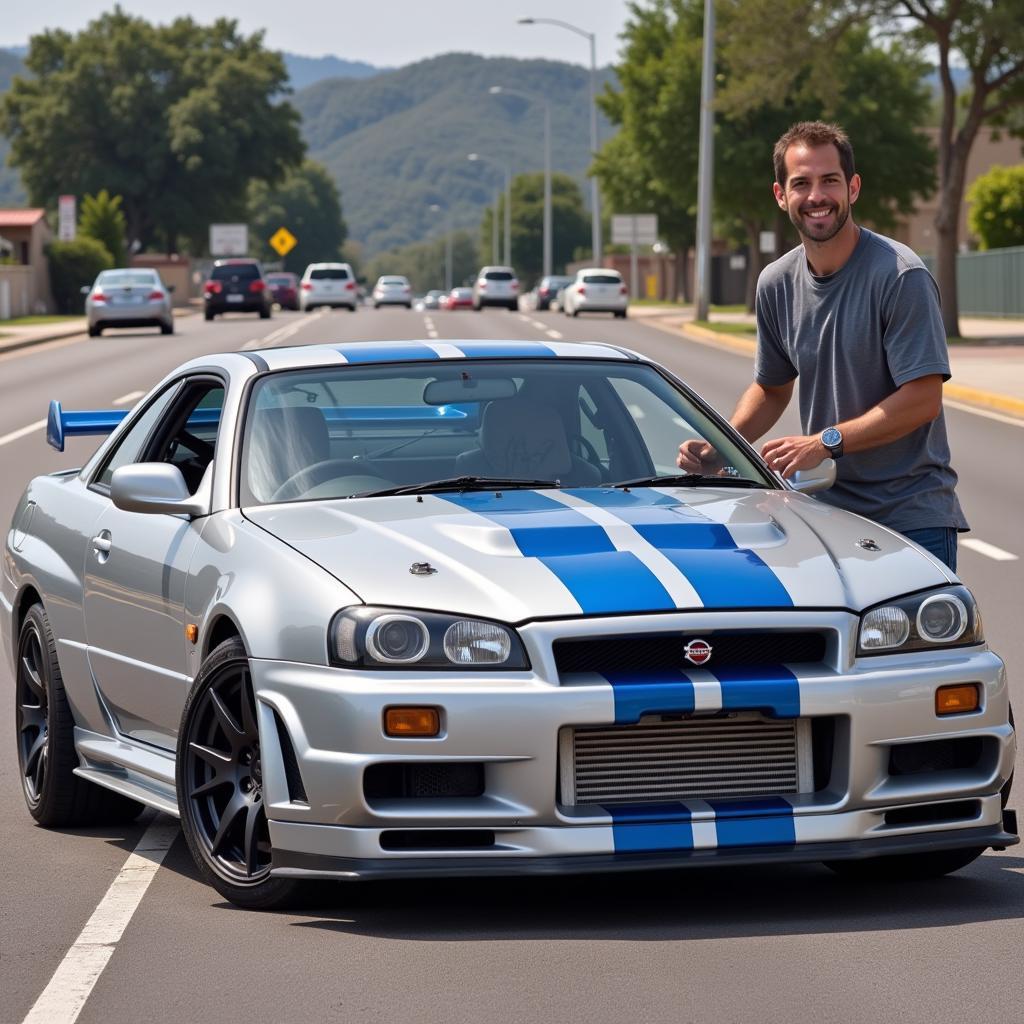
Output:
(580, 488), (793, 608)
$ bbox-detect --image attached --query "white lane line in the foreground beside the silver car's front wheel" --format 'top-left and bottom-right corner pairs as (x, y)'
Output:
(23, 815), (181, 1024)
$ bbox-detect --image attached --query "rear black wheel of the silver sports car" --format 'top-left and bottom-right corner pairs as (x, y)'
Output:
(14, 604), (142, 828)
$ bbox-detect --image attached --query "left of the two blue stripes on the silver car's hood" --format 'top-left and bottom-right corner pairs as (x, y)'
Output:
(437, 490), (675, 614)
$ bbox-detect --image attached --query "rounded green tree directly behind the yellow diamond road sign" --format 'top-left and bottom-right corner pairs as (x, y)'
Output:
(249, 160), (348, 273)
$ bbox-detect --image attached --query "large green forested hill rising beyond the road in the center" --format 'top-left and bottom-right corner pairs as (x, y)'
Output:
(292, 53), (611, 255)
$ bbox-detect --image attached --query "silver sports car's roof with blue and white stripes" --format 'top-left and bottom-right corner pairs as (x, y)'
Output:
(211, 339), (640, 371)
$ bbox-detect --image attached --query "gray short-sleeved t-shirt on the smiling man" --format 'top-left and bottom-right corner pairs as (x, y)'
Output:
(754, 227), (968, 531)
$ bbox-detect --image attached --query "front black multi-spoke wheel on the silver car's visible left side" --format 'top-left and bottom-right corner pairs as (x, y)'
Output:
(175, 637), (300, 910)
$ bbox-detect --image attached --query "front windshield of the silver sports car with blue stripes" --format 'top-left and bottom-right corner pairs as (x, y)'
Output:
(241, 358), (773, 506)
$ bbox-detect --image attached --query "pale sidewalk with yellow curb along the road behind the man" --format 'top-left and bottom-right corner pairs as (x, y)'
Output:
(630, 304), (1024, 420)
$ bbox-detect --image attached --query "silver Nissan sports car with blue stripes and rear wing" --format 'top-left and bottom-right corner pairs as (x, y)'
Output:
(0, 341), (1018, 908)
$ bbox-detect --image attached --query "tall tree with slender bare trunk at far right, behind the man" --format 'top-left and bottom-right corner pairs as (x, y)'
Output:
(720, 0), (1024, 337)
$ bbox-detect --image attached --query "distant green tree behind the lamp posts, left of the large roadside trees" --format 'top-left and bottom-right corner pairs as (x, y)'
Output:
(478, 171), (590, 287)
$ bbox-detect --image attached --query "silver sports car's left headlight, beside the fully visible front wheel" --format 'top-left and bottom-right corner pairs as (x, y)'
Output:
(330, 606), (529, 669)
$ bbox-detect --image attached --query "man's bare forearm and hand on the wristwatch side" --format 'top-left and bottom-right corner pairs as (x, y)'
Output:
(761, 374), (942, 476)
